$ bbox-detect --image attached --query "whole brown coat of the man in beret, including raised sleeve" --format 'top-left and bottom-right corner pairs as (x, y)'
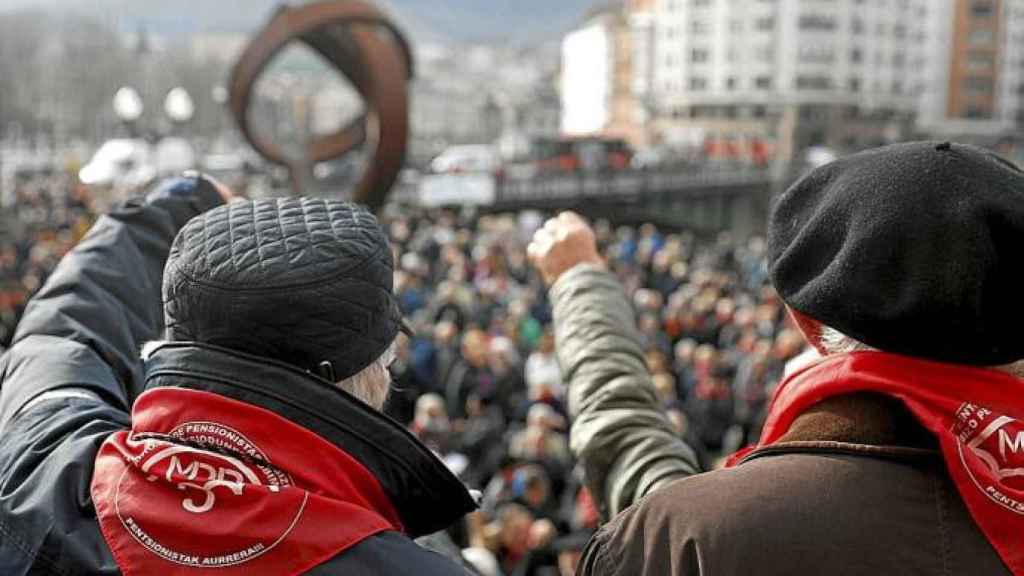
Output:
(551, 266), (1009, 576)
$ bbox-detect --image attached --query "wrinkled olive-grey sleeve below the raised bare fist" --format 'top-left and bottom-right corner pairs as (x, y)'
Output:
(551, 264), (698, 521)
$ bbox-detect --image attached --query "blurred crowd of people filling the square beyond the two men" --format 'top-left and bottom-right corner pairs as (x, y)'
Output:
(0, 174), (804, 575)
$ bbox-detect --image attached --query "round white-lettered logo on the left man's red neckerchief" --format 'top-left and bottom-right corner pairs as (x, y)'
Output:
(115, 422), (308, 568)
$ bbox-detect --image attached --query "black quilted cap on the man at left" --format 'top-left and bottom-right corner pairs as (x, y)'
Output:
(164, 198), (402, 380)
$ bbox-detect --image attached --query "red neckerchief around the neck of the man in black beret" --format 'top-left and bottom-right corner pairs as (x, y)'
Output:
(730, 352), (1024, 574)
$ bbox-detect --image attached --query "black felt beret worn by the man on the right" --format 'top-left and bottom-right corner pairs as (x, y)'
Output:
(768, 142), (1024, 366)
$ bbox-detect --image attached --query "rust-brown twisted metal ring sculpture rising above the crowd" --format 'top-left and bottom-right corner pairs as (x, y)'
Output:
(229, 0), (413, 210)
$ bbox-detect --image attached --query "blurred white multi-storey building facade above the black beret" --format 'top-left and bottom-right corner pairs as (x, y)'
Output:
(651, 0), (932, 153)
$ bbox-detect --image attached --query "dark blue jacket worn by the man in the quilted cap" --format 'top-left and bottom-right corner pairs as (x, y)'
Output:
(0, 180), (474, 576)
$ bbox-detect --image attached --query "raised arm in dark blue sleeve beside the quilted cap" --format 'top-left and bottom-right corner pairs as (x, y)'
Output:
(0, 178), (227, 429)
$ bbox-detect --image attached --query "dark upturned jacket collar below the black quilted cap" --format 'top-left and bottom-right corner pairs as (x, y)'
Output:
(145, 342), (476, 537)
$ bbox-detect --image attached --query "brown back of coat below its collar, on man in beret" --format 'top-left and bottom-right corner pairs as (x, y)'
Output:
(578, 442), (1010, 576)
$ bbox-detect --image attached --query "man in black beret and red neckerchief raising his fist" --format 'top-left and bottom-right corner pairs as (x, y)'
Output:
(530, 142), (1024, 576)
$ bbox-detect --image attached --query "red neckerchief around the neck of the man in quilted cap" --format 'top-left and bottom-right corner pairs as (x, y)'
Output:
(92, 388), (401, 576)
